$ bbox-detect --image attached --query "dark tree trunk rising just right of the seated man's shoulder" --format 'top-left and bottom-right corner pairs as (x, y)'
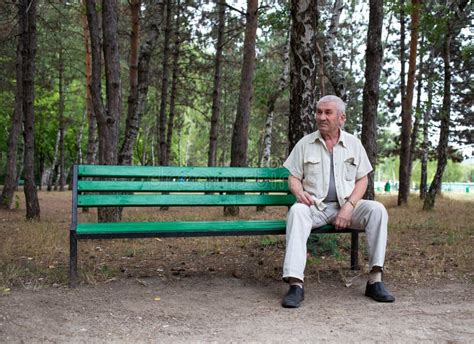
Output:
(361, 0), (383, 200)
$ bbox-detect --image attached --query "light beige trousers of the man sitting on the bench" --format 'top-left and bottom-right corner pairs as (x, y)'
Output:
(283, 200), (388, 281)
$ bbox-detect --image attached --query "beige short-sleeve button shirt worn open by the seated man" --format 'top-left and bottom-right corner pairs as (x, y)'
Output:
(283, 130), (372, 206)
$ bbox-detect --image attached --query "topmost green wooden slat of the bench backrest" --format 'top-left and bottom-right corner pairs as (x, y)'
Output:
(78, 165), (289, 179)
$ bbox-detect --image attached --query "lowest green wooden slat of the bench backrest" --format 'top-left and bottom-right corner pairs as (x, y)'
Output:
(78, 194), (295, 207)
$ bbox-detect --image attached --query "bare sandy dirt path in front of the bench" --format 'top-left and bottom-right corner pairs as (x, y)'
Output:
(0, 276), (474, 343)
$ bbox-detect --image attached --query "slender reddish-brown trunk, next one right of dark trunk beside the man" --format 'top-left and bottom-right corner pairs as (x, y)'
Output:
(398, 0), (420, 205)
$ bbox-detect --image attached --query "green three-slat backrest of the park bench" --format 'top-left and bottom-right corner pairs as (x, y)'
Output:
(74, 165), (295, 207)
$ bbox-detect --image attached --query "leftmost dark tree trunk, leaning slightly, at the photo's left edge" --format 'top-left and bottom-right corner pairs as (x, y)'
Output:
(0, 29), (23, 209)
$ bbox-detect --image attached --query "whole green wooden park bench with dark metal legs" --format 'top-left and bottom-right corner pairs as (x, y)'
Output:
(69, 165), (361, 287)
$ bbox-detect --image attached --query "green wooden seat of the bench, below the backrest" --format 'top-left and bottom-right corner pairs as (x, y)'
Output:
(76, 220), (334, 236)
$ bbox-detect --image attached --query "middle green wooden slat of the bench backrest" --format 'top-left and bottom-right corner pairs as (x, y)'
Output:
(77, 180), (288, 192)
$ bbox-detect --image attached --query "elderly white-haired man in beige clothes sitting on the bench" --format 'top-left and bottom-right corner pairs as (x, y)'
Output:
(282, 96), (395, 308)
